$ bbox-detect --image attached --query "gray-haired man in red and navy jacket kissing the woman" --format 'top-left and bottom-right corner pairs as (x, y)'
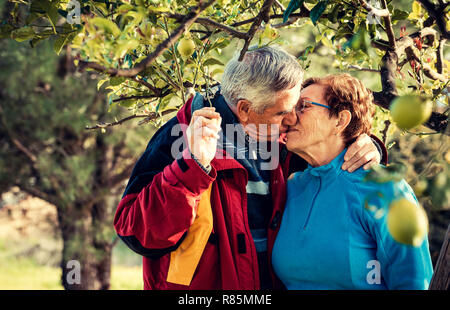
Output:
(114, 47), (386, 290)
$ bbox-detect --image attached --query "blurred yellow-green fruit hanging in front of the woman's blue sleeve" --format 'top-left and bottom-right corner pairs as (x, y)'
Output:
(387, 198), (428, 247)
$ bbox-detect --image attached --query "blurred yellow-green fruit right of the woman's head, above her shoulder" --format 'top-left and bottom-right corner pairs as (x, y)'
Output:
(390, 95), (433, 130)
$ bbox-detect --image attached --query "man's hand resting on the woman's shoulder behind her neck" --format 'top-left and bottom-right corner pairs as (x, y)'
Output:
(342, 134), (381, 172)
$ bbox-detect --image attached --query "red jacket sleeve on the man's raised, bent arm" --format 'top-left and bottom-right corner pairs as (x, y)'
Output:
(114, 149), (216, 256)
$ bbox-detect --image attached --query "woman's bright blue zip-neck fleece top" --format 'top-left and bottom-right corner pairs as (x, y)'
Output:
(272, 149), (433, 289)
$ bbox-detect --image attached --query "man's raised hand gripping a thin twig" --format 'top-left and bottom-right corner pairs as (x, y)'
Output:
(186, 107), (222, 167)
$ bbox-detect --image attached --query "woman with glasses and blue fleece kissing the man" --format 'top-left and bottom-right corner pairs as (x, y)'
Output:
(272, 74), (432, 289)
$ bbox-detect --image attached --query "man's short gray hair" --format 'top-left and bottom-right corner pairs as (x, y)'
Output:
(221, 46), (303, 113)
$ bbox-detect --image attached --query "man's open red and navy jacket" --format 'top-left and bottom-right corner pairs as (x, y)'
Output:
(114, 95), (300, 290)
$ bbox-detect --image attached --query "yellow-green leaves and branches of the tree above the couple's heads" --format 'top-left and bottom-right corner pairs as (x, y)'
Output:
(0, 0), (450, 132)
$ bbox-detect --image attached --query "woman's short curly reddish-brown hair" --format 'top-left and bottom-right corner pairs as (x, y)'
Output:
(302, 73), (375, 146)
